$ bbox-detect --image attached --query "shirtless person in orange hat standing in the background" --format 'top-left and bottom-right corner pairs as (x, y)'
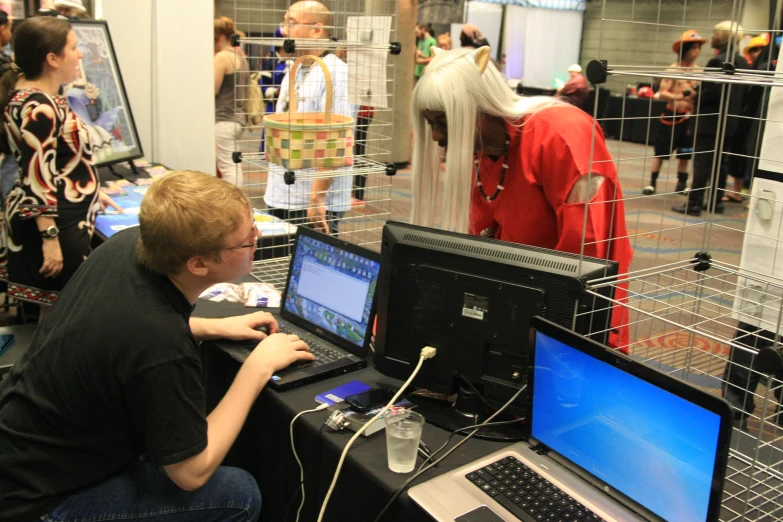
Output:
(642, 29), (707, 196)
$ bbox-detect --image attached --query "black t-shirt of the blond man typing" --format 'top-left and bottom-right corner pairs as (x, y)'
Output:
(0, 228), (207, 522)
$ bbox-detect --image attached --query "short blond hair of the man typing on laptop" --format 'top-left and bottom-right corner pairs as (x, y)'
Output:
(136, 170), (251, 275)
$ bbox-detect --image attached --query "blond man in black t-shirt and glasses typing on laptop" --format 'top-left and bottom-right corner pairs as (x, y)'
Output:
(0, 171), (313, 522)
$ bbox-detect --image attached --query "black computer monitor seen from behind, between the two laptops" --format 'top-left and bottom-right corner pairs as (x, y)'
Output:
(374, 221), (618, 438)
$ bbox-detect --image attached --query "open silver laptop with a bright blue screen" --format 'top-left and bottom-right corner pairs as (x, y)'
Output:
(409, 317), (732, 522)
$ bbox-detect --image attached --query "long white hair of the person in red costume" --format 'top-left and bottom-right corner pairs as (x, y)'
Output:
(411, 47), (564, 233)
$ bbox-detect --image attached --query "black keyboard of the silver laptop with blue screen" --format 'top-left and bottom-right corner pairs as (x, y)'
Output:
(466, 457), (603, 522)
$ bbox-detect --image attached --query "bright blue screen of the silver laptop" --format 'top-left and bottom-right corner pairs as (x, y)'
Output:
(531, 332), (721, 522)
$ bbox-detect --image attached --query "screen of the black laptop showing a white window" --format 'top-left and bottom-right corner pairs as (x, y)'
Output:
(283, 235), (381, 347)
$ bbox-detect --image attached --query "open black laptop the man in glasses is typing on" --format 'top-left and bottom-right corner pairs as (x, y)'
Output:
(270, 227), (381, 390)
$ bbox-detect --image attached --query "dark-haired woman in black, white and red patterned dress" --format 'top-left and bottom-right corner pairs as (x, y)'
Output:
(0, 17), (115, 306)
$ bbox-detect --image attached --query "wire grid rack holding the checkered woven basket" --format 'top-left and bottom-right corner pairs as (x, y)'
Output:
(222, 0), (399, 282)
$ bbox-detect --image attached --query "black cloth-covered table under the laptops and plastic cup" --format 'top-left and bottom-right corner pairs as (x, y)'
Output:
(194, 300), (505, 522)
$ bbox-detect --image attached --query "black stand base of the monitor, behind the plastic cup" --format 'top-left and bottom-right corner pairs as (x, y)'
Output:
(406, 385), (525, 442)
